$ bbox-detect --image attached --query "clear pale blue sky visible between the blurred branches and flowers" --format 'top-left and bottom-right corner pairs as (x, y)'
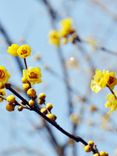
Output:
(0, 0), (117, 156)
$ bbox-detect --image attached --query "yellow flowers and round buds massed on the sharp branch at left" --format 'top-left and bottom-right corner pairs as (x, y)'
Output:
(0, 44), (57, 122)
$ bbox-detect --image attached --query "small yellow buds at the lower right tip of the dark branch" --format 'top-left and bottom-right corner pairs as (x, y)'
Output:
(84, 140), (109, 156)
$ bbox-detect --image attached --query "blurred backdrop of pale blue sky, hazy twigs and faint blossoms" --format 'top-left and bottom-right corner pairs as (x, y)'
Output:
(0, 0), (117, 156)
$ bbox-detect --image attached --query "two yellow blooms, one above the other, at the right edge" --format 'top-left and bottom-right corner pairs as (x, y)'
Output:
(91, 69), (117, 112)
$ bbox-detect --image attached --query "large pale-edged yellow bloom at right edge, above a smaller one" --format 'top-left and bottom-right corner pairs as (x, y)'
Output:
(91, 69), (117, 93)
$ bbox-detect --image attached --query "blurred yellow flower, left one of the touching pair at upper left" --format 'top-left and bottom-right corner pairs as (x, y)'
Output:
(7, 44), (19, 56)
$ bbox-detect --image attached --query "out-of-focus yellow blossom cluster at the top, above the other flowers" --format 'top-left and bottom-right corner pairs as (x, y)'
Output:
(49, 18), (77, 46)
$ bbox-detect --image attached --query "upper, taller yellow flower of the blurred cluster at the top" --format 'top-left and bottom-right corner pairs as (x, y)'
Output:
(60, 18), (73, 37)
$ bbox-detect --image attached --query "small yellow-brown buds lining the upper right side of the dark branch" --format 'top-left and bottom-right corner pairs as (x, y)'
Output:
(38, 93), (57, 122)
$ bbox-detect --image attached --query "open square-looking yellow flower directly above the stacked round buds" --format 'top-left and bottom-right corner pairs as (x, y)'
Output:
(23, 67), (42, 84)
